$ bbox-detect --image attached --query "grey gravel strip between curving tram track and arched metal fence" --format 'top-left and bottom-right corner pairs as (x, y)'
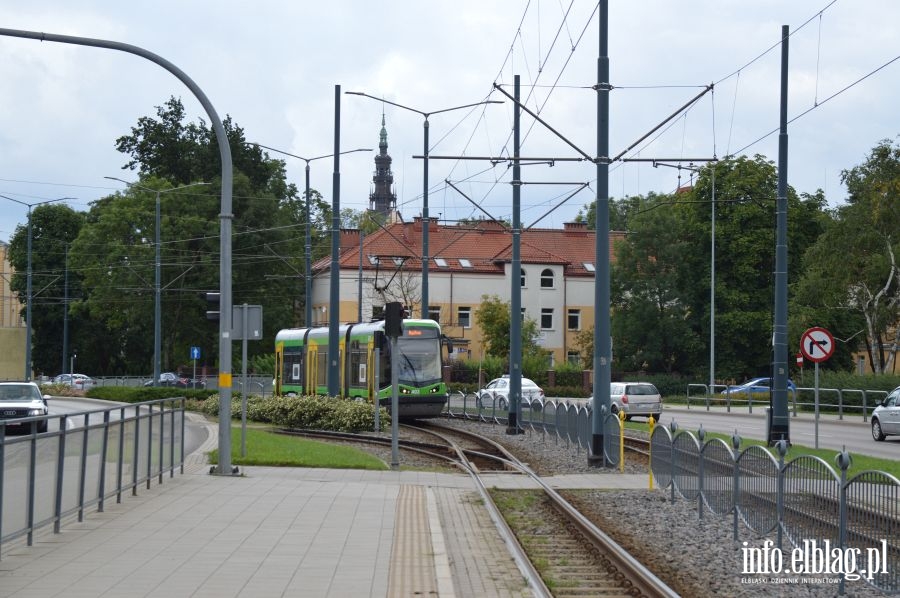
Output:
(438, 420), (884, 598)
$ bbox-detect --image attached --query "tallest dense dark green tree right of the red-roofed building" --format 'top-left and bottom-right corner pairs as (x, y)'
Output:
(673, 155), (824, 379)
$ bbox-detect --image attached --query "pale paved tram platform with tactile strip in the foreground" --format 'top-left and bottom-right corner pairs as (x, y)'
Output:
(0, 414), (647, 598)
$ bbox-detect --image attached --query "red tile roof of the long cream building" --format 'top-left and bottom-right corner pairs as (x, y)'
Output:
(313, 218), (625, 277)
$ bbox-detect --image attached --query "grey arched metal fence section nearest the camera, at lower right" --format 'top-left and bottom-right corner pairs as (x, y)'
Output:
(650, 425), (900, 594)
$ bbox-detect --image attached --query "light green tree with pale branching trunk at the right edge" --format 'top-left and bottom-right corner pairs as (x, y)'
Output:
(798, 140), (900, 373)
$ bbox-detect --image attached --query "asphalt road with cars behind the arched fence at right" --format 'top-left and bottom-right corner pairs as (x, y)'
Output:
(652, 405), (900, 459)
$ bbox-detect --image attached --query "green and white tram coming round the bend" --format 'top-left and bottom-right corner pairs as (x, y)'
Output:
(275, 319), (447, 419)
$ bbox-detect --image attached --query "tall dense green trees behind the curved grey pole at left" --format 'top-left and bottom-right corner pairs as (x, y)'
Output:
(72, 98), (300, 373)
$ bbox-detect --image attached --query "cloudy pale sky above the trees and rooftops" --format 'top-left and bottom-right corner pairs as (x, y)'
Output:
(0, 0), (900, 241)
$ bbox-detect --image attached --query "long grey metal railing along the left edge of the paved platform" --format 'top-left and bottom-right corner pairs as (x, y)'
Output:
(0, 398), (185, 550)
